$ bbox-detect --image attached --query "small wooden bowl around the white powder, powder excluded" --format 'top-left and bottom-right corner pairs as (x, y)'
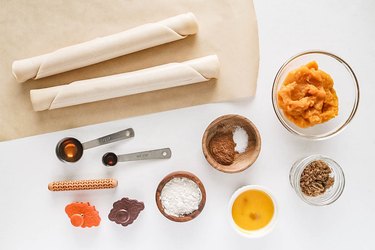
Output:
(155, 171), (206, 222)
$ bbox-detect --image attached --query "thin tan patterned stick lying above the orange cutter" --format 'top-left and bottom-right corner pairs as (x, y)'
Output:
(48, 178), (118, 191)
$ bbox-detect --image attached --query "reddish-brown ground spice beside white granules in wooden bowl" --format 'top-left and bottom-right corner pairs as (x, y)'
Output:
(209, 133), (236, 165)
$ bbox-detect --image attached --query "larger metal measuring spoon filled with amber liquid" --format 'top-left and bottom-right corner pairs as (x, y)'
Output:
(56, 128), (134, 162)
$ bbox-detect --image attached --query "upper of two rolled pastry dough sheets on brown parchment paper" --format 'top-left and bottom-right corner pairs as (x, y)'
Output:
(12, 13), (198, 82)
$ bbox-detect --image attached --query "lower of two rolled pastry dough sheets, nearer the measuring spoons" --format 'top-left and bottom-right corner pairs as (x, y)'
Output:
(30, 55), (219, 111)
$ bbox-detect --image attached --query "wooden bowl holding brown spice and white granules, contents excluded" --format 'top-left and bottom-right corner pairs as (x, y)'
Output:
(202, 115), (261, 173)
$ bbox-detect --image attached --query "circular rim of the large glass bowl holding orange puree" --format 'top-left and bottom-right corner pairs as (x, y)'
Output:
(271, 50), (360, 140)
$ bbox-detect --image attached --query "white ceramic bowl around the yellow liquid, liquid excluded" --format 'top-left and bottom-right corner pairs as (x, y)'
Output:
(228, 185), (278, 238)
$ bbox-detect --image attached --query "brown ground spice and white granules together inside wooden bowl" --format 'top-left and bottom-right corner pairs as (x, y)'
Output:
(209, 127), (248, 165)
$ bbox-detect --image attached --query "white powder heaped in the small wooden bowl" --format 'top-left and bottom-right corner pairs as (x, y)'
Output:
(160, 177), (202, 217)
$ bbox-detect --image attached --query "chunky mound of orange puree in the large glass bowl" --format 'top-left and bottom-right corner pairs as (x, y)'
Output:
(277, 61), (339, 128)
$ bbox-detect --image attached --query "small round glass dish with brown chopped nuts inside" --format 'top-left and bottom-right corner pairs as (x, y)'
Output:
(289, 155), (345, 206)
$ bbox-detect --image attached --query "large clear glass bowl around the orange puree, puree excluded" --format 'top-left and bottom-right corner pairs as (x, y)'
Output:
(272, 51), (359, 140)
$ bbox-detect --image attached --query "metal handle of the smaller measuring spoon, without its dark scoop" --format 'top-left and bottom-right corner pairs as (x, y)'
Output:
(117, 148), (172, 162)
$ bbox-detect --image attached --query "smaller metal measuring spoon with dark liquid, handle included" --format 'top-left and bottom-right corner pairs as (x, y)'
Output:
(102, 148), (172, 167)
